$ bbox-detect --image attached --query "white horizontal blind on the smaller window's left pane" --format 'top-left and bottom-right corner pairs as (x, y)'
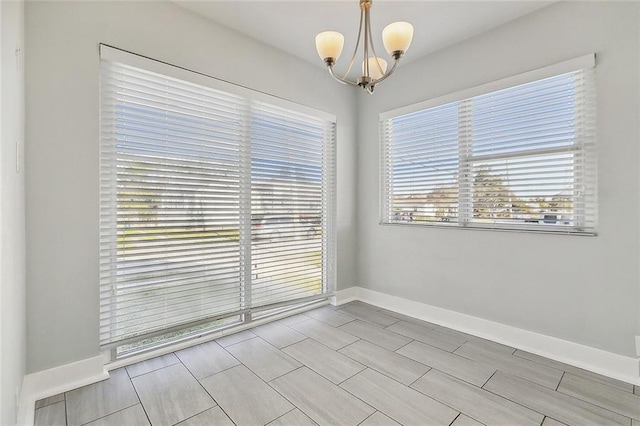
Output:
(381, 102), (460, 222)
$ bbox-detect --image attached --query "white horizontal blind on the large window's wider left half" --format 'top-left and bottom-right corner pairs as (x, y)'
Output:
(100, 61), (244, 344)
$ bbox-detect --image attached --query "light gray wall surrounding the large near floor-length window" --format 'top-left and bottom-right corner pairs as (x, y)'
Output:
(26, 1), (356, 372)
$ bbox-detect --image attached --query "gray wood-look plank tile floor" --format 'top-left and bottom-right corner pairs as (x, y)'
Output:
(35, 302), (640, 426)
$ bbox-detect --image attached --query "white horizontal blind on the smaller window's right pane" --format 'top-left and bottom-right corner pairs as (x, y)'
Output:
(462, 70), (596, 232)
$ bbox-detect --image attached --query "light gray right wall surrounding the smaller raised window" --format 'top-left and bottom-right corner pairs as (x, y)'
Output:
(358, 2), (640, 356)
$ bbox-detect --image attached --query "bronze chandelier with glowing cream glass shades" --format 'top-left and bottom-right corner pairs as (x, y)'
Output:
(316, 0), (413, 93)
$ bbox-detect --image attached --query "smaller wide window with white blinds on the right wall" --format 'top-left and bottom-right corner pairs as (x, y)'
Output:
(380, 55), (597, 235)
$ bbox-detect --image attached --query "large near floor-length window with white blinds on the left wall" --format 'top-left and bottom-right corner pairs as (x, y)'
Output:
(100, 46), (335, 357)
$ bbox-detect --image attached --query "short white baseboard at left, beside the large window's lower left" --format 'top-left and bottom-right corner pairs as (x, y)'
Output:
(18, 356), (109, 426)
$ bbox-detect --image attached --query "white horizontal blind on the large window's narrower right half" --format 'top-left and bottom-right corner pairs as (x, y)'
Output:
(251, 102), (334, 306)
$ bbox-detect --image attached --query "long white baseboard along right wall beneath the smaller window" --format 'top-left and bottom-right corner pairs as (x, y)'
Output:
(335, 287), (640, 386)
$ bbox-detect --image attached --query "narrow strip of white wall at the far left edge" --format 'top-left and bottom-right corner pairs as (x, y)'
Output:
(0, 1), (26, 425)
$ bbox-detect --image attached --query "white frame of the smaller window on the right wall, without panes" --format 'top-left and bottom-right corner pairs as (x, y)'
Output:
(379, 53), (598, 236)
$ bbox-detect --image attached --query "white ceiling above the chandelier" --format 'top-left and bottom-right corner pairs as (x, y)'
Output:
(174, 0), (553, 66)
